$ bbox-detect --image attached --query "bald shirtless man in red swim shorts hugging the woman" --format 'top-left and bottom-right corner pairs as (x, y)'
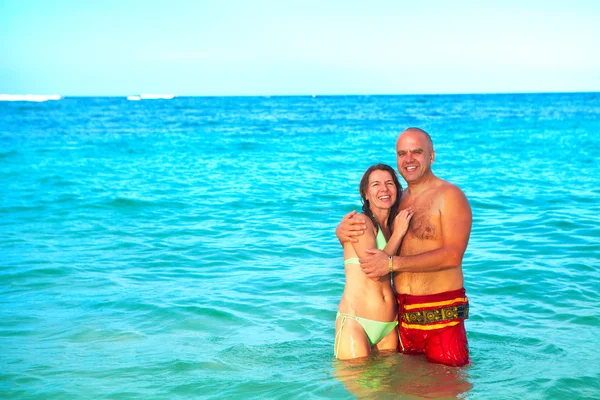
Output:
(336, 128), (472, 366)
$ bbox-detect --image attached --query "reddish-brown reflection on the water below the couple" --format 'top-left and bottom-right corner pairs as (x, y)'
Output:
(333, 353), (473, 399)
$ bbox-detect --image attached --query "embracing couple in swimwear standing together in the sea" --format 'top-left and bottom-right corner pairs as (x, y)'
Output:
(334, 128), (472, 366)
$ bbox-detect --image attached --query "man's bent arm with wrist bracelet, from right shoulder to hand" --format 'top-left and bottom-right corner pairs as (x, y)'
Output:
(360, 186), (473, 278)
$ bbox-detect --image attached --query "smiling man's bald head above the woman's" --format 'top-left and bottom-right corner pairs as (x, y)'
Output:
(396, 128), (435, 184)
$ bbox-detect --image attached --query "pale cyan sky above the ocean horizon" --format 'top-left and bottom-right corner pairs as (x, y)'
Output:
(0, 0), (600, 96)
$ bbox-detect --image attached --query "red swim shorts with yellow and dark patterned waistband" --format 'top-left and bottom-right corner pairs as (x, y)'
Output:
(396, 289), (469, 367)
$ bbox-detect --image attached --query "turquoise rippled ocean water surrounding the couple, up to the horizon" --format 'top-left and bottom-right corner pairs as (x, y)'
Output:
(0, 93), (600, 399)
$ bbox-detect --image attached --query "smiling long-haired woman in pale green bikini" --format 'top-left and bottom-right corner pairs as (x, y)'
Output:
(334, 164), (413, 360)
